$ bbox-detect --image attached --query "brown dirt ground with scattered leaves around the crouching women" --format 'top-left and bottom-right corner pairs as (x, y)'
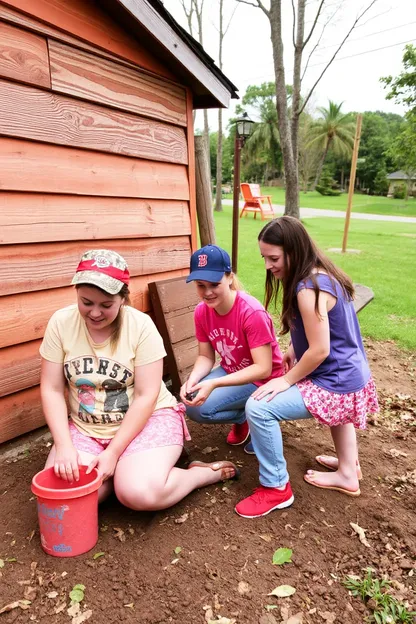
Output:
(0, 341), (416, 624)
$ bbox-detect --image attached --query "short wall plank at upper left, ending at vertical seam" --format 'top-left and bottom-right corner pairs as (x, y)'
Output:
(0, 22), (51, 88)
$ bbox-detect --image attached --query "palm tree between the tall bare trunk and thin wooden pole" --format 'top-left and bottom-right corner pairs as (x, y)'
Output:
(308, 100), (355, 189)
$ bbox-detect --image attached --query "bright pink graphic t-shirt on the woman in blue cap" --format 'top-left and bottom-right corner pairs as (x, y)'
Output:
(194, 290), (284, 386)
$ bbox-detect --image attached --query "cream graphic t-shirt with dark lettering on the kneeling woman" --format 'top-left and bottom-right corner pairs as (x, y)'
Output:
(40, 305), (176, 438)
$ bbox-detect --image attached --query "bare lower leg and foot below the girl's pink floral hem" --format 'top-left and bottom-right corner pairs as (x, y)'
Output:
(306, 423), (359, 492)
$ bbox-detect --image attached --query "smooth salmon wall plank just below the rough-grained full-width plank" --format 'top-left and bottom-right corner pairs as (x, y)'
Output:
(0, 138), (189, 200)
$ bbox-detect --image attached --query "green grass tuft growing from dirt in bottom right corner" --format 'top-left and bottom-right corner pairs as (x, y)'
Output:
(343, 568), (416, 624)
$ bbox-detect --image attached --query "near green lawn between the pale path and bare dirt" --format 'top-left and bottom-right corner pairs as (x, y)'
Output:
(214, 206), (416, 350)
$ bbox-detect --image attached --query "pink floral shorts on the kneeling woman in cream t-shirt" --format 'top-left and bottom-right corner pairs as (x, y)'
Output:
(69, 403), (191, 459)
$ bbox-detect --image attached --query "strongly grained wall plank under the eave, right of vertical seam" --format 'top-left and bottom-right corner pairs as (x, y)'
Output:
(49, 41), (187, 126)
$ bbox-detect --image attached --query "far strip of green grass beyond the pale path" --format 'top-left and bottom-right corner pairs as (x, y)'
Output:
(225, 186), (416, 217)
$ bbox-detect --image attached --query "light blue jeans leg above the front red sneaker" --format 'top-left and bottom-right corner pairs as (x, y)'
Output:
(246, 385), (312, 487)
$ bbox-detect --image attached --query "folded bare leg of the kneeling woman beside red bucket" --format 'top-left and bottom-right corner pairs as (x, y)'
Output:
(114, 445), (237, 510)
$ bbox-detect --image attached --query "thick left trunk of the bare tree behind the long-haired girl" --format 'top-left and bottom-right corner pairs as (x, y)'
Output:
(269, 0), (300, 219)
